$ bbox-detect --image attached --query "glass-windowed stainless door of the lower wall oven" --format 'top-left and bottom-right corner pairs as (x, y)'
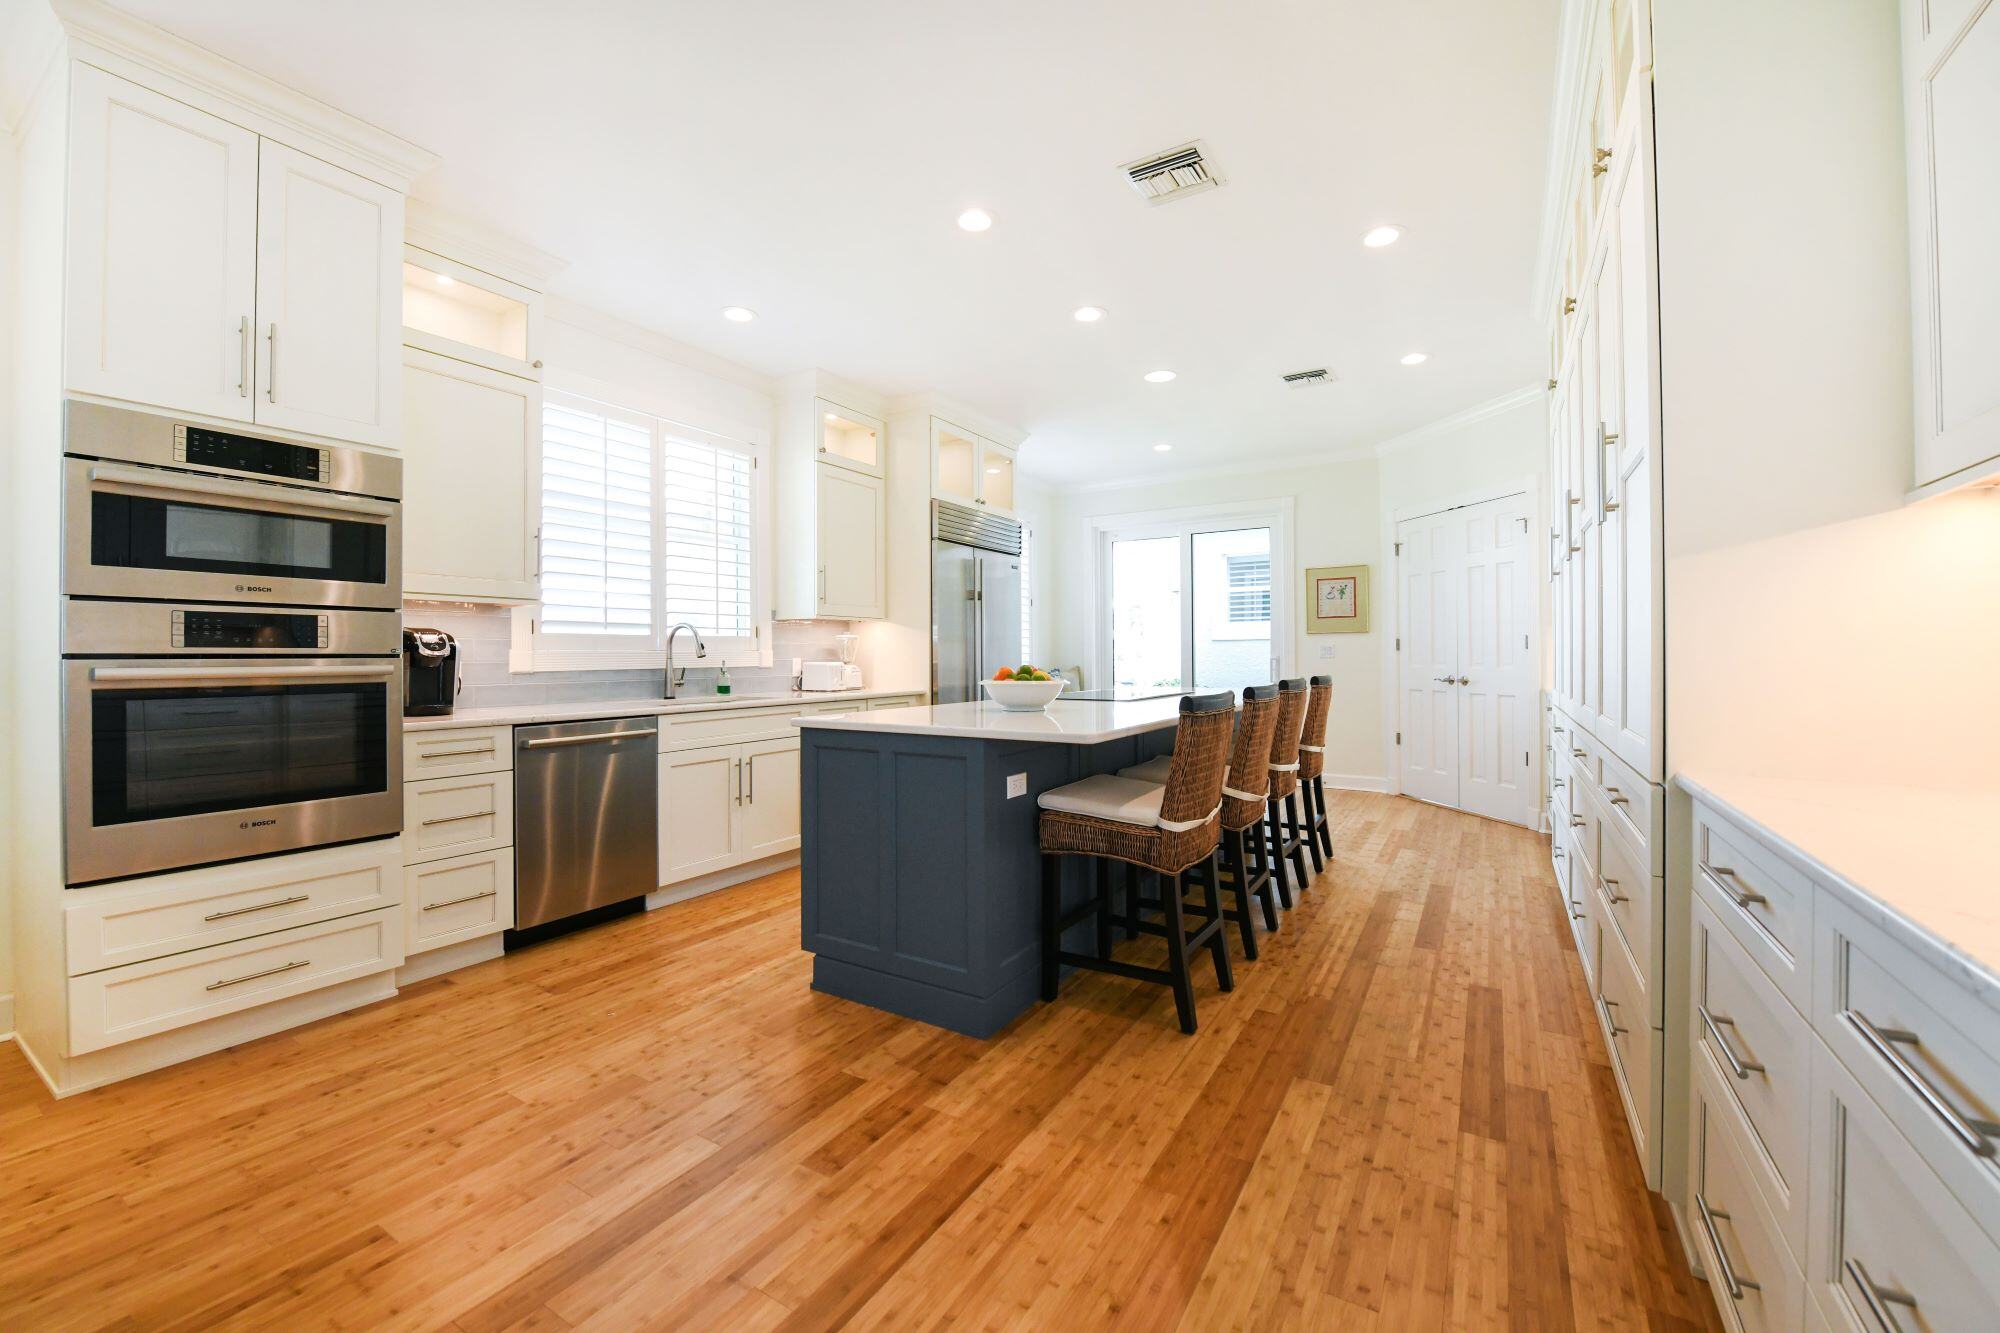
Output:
(66, 658), (402, 883)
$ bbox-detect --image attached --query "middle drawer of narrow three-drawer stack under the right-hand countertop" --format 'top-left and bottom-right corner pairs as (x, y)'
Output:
(1690, 901), (1812, 1257)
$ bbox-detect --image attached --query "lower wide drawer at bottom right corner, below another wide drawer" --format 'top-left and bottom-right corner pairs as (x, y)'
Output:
(1806, 1043), (2000, 1329)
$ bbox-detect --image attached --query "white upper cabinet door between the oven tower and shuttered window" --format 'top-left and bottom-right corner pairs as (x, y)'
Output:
(402, 348), (542, 602)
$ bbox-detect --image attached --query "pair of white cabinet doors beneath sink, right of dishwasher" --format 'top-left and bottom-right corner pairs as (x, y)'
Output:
(660, 735), (798, 887)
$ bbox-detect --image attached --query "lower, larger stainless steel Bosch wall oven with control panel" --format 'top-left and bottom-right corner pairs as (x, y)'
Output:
(62, 600), (402, 885)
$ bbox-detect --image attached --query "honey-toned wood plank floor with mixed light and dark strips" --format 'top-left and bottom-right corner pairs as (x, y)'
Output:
(0, 795), (1720, 1331)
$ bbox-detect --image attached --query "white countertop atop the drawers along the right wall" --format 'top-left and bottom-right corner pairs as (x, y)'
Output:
(1678, 773), (2000, 1007)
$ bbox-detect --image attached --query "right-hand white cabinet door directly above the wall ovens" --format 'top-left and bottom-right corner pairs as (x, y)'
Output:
(256, 140), (402, 446)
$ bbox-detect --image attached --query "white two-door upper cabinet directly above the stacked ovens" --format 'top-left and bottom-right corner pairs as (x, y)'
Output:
(66, 64), (402, 446)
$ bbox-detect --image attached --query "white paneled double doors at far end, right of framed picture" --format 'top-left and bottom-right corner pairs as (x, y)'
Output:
(1396, 494), (1540, 825)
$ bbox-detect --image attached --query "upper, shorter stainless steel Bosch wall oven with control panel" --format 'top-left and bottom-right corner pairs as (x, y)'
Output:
(62, 402), (402, 610)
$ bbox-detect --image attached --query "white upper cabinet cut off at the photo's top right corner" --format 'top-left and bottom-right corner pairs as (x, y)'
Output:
(1902, 0), (2000, 488)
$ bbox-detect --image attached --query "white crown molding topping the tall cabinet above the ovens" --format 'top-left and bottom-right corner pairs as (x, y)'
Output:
(51, 0), (438, 194)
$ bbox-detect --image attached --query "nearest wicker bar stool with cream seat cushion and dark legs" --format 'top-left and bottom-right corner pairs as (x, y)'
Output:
(1038, 693), (1236, 1033)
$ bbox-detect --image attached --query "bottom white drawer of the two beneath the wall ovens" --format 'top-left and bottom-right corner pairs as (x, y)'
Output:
(70, 907), (402, 1055)
